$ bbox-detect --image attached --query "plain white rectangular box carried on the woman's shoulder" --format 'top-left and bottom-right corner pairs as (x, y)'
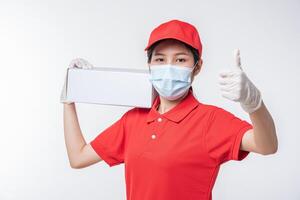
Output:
(66, 67), (157, 108)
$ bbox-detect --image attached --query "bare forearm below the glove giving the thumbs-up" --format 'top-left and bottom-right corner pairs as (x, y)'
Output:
(250, 102), (278, 154)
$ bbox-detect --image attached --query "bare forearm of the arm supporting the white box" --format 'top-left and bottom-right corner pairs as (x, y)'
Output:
(64, 103), (86, 167)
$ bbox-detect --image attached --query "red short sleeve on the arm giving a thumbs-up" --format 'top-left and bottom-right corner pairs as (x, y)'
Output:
(204, 108), (253, 164)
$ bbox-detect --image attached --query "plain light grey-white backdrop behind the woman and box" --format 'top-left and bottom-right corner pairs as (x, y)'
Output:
(0, 0), (300, 200)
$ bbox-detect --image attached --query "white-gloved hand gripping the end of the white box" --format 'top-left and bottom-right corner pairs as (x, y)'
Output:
(60, 58), (94, 104)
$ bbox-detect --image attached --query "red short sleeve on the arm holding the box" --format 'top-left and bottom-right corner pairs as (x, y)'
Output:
(90, 112), (127, 167)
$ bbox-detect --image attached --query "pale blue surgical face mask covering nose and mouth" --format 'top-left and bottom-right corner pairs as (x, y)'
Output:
(149, 61), (198, 100)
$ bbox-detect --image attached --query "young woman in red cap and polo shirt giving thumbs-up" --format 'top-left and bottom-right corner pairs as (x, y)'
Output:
(61, 20), (278, 200)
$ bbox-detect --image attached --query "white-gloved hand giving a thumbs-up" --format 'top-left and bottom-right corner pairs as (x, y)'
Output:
(219, 49), (262, 114)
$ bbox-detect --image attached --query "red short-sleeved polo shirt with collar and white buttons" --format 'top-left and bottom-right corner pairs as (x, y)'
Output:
(90, 90), (253, 200)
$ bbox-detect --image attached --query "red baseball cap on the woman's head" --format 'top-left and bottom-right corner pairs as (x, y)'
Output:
(145, 19), (202, 58)
